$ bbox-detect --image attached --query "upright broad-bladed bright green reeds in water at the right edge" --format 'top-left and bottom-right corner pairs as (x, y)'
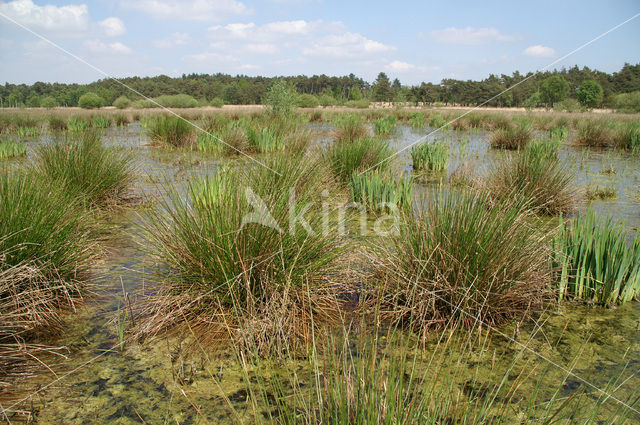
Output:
(552, 210), (640, 305)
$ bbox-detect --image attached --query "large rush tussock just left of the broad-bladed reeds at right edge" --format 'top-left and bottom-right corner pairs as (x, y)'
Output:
(372, 190), (550, 331)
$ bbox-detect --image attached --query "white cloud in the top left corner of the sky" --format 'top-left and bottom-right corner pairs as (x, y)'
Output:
(0, 0), (91, 33)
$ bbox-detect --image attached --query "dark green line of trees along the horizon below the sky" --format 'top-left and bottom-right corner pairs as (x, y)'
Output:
(0, 63), (640, 107)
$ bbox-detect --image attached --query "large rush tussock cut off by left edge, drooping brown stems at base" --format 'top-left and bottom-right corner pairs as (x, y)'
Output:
(0, 168), (97, 381)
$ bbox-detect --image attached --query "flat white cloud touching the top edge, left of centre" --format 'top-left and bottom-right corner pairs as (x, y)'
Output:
(120, 0), (251, 22)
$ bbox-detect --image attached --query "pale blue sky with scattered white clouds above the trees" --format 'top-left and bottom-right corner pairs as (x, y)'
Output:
(0, 0), (640, 84)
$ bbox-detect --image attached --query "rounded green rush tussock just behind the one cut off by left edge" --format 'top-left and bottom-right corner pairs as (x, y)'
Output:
(33, 130), (134, 207)
